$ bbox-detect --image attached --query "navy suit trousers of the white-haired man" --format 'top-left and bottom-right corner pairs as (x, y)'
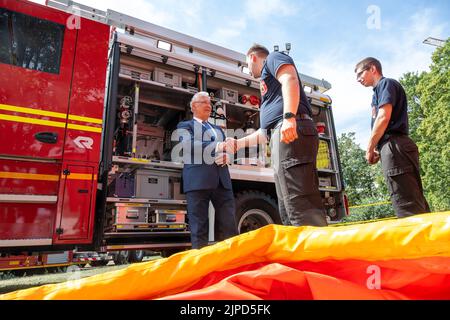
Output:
(186, 185), (238, 249)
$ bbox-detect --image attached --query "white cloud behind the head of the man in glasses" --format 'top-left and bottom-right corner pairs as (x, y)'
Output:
(307, 9), (446, 148)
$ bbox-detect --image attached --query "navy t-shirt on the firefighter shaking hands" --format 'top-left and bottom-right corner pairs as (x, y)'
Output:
(260, 52), (311, 129)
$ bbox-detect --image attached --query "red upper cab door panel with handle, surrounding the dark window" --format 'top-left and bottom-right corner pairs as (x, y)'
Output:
(0, 0), (77, 159)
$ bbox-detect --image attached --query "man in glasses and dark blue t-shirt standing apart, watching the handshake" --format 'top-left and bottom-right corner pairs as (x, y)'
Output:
(355, 58), (430, 218)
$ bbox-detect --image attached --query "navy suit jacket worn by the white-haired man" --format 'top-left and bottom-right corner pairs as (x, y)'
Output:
(177, 119), (232, 192)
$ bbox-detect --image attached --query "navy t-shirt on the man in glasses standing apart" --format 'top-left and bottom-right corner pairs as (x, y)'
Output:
(372, 77), (409, 134)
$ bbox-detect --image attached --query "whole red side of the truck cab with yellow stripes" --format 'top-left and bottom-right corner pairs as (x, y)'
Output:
(0, 0), (110, 245)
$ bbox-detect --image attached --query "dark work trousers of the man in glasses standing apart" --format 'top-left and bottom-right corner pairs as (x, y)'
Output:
(380, 135), (430, 218)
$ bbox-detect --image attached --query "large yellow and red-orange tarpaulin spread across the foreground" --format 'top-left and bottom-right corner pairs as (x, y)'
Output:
(0, 213), (450, 300)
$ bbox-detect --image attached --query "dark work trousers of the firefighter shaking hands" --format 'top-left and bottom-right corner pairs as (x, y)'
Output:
(270, 120), (327, 227)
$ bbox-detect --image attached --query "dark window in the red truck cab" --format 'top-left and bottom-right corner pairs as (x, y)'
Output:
(0, 8), (64, 74)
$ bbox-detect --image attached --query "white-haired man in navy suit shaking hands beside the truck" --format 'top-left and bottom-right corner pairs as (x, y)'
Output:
(177, 92), (238, 249)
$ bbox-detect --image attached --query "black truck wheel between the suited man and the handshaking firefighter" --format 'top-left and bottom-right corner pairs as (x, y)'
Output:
(235, 191), (281, 234)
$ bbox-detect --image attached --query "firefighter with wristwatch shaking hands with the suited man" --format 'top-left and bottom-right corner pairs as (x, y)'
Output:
(232, 45), (327, 227)
